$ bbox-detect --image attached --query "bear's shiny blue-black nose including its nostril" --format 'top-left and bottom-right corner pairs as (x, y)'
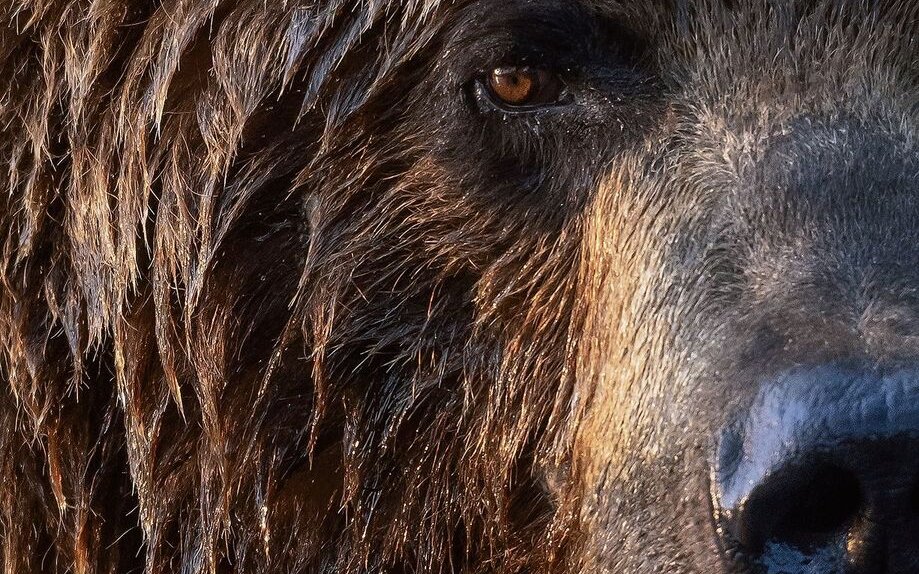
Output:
(713, 366), (919, 574)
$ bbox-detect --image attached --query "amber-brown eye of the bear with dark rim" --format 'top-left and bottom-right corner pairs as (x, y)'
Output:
(485, 67), (565, 111)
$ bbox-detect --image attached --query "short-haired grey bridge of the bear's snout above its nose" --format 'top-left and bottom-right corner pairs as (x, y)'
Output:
(726, 118), (919, 364)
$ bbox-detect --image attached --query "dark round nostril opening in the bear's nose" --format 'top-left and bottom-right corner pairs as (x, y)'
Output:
(746, 465), (862, 550)
